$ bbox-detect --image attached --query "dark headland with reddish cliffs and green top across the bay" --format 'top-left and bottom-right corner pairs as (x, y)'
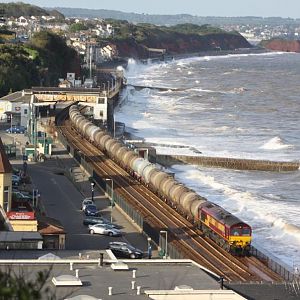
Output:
(100, 19), (251, 58)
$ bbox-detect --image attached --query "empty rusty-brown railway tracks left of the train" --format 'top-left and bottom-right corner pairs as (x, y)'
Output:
(58, 109), (282, 282)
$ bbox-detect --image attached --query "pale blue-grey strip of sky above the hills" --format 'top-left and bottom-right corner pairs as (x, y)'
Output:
(0, 0), (300, 18)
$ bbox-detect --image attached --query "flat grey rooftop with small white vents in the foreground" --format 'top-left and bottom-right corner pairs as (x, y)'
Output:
(0, 250), (300, 300)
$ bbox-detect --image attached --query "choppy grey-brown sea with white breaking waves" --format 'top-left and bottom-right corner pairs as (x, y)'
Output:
(115, 52), (300, 267)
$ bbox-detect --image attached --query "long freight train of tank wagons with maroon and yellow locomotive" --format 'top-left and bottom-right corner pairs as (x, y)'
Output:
(69, 105), (252, 255)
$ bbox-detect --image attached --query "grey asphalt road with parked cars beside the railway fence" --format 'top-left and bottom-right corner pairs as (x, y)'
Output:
(24, 158), (147, 251)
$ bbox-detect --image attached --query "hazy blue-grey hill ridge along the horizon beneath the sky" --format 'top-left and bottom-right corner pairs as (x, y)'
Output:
(55, 7), (300, 26)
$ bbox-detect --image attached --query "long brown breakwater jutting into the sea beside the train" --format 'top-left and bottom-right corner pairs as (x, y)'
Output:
(156, 154), (300, 172)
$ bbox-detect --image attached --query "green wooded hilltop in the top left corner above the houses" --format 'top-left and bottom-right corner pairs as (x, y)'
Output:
(0, 2), (64, 18)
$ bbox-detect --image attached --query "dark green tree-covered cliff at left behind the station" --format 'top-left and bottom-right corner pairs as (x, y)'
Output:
(0, 31), (80, 96)
